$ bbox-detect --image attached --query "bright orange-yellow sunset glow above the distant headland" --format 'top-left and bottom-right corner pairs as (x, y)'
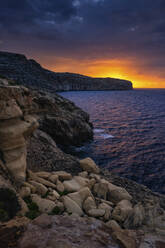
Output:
(40, 58), (165, 88)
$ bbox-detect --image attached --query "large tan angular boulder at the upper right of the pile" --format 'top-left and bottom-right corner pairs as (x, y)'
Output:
(107, 183), (132, 204)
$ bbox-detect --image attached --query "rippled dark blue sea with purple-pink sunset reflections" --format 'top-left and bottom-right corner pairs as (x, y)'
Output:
(60, 89), (165, 193)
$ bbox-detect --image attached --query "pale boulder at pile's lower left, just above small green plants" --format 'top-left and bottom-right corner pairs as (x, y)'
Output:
(31, 194), (56, 213)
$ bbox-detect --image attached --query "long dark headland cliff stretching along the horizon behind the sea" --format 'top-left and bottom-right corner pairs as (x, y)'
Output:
(0, 52), (132, 92)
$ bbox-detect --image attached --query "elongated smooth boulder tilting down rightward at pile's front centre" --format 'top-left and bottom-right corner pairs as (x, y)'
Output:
(62, 196), (83, 216)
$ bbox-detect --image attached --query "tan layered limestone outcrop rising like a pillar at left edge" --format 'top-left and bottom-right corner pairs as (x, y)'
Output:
(0, 86), (38, 183)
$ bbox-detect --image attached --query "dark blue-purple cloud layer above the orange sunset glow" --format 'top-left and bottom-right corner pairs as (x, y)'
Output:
(0, 0), (165, 78)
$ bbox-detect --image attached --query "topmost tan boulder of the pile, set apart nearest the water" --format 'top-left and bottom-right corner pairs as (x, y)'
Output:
(80, 158), (100, 174)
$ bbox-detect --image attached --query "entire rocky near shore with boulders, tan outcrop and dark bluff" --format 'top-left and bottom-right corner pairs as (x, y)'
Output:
(0, 79), (165, 248)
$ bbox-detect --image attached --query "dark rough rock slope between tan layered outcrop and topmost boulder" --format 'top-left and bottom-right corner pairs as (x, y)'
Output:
(27, 130), (81, 174)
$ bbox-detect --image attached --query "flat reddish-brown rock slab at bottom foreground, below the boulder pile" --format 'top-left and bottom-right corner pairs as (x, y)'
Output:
(18, 215), (124, 248)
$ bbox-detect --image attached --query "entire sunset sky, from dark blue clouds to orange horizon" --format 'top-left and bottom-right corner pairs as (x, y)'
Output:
(0, 0), (165, 88)
